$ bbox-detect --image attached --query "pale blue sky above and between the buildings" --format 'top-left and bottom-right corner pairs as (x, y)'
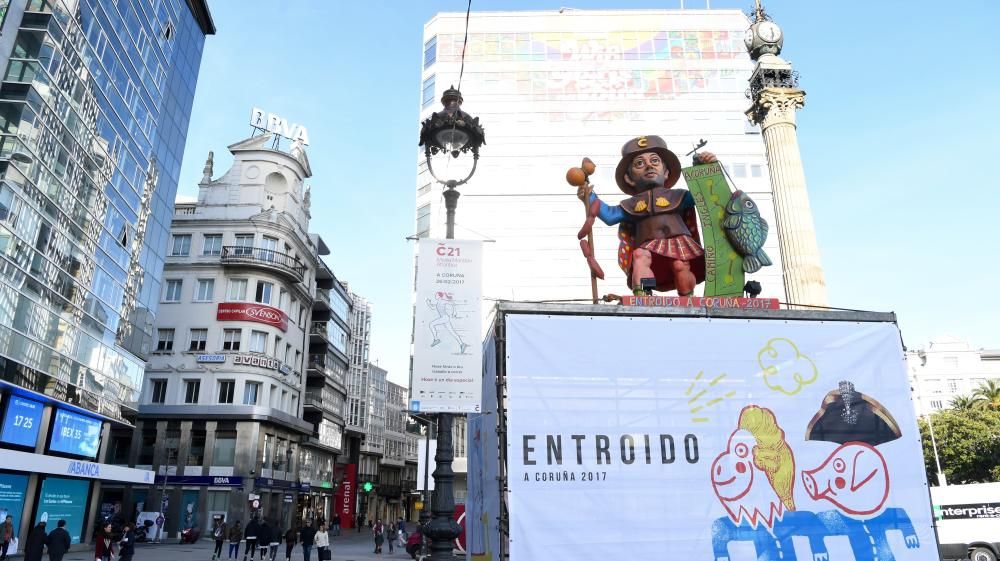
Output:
(178, 0), (1000, 383)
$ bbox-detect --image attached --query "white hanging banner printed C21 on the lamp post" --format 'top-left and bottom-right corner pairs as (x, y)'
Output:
(410, 239), (482, 413)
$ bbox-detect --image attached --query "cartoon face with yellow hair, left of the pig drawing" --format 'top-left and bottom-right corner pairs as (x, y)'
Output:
(711, 405), (795, 528)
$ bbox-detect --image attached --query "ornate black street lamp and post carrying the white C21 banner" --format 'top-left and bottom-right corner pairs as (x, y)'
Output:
(419, 87), (486, 561)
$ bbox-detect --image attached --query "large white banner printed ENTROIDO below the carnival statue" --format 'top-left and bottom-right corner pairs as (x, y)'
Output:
(506, 315), (938, 561)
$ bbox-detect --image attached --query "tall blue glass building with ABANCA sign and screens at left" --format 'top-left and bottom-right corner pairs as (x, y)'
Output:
(0, 0), (215, 553)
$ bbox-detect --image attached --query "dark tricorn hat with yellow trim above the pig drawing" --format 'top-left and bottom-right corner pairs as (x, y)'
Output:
(806, 381), (902, 446)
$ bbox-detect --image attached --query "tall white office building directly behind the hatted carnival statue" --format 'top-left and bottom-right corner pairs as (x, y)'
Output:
(415, 9), (785, 302)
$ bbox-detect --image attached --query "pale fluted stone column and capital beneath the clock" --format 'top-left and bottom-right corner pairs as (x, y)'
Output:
(747, 87), (827, 306)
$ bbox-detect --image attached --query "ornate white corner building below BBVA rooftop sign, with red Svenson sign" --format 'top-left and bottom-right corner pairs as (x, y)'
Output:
(127, 135), (346, 527)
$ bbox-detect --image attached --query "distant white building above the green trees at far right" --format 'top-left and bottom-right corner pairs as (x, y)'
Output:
(906, 337), (1000, 415)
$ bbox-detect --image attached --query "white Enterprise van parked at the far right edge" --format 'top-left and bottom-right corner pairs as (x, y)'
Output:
(931, 483), (1000, 561)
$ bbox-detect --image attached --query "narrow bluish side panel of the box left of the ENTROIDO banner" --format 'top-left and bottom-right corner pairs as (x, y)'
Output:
(465, 337), (500, 561)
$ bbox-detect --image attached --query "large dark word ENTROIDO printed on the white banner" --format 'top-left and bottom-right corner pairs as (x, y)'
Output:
(521, 434), (698, 466)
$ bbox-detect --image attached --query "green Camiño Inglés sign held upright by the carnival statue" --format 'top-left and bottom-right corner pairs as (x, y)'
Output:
(682, 162), (744, 296)
